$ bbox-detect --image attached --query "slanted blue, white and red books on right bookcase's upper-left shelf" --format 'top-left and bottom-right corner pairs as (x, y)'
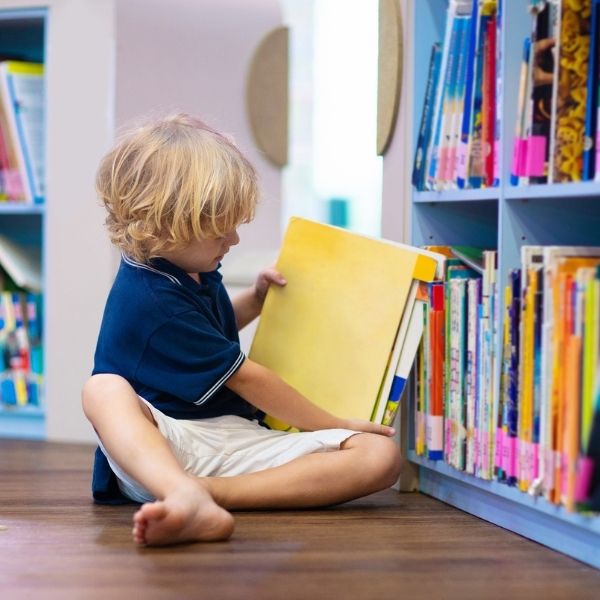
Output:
(412, 0), (502, 190)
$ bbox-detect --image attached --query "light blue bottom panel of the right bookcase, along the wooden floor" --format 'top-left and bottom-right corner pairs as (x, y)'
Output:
(409, 451), (600, 568)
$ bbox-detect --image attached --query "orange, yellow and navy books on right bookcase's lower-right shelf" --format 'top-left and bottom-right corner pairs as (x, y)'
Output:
(495, 246), (600, 511)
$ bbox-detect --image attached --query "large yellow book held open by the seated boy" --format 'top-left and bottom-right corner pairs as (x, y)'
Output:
(249, 218), (437, 429)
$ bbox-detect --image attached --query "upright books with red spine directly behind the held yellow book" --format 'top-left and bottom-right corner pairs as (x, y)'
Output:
(415, 246), (497, 479)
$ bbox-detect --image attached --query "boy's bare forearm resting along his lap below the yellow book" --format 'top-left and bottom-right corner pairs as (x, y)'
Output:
(226, 359), (394, 436)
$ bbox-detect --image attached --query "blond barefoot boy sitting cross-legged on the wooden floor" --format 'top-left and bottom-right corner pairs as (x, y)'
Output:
(83, 115), (401, 545)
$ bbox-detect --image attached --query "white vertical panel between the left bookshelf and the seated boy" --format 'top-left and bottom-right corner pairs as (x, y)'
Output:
(44, 0), (114, 440)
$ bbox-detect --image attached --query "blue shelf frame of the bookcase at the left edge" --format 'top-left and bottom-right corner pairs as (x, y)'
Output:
(0, 7), (48, 439)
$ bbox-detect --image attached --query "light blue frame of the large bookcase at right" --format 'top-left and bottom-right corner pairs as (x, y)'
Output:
(408, 0), (600, 568)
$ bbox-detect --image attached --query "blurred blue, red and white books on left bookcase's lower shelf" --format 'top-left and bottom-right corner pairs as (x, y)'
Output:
(0, 291), (43, 408)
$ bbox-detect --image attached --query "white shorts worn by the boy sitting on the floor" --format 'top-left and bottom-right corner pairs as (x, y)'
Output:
(98, 398), (357, 503)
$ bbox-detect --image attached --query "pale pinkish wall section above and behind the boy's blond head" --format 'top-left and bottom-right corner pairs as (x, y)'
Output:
(116, 0), (282, 258)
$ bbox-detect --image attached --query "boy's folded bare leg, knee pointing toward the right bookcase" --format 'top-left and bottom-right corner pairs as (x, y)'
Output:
(202, 433), (402, 510)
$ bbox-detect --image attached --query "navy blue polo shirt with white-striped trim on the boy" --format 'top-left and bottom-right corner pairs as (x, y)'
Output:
(92, 256), (256, 501)
